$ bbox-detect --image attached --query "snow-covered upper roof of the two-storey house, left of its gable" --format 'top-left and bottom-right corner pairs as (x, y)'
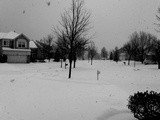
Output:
(0, 31), (20, 39)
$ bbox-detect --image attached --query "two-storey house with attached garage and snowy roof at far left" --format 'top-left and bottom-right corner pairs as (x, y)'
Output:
(0, 31), (31, 63)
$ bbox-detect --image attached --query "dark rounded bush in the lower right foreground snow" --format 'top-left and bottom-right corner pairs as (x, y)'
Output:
(127, 91), (160, 120)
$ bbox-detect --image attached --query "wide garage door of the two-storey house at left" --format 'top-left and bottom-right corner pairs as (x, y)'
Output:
(7, 55), (27, 63)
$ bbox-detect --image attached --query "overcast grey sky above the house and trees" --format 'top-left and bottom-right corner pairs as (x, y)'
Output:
(0, 0), (160, 50)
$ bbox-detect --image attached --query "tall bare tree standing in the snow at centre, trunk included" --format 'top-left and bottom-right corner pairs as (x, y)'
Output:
(54, 0), (91, 78)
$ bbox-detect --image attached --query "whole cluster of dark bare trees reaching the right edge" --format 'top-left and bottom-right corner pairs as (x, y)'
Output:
(121, 31), (160, 69)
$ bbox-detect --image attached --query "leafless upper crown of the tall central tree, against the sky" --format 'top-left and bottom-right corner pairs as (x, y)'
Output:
(60, 0), (91, 41)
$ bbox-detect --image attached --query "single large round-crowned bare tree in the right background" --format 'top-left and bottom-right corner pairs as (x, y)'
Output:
(123, 31), (154, 65)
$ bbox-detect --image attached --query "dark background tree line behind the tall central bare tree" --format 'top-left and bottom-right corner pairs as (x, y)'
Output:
(35, 31), (109, 68)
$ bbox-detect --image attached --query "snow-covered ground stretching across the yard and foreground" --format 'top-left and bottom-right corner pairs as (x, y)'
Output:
(0, 61), (160, 120)
